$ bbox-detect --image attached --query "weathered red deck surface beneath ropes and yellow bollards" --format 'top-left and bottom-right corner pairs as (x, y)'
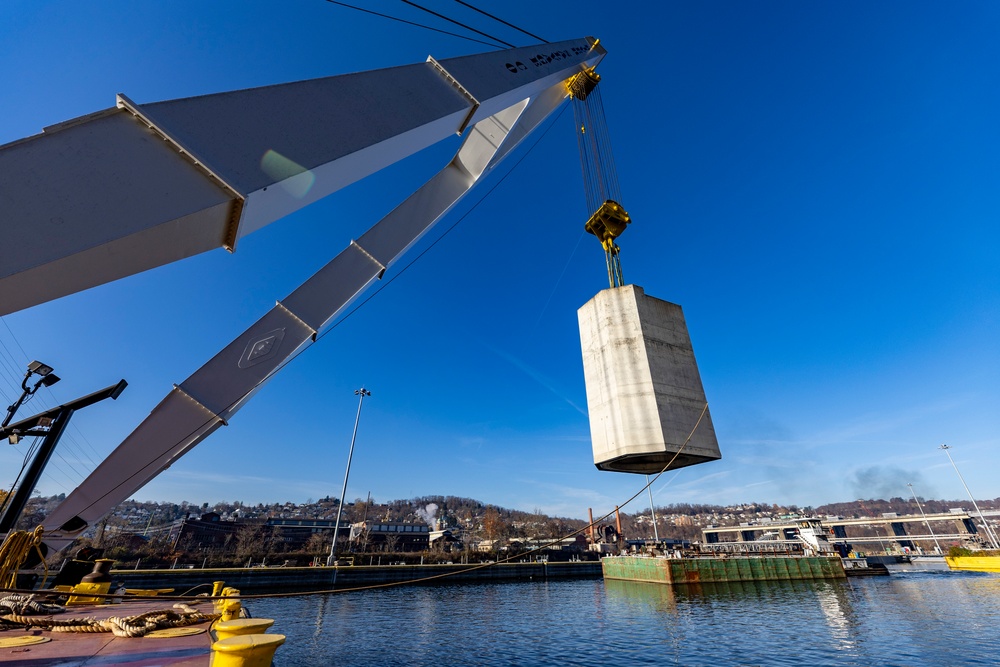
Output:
(0, 599), (212, 667)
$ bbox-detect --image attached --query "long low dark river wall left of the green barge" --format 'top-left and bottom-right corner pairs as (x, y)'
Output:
(111, 561), (601, 594)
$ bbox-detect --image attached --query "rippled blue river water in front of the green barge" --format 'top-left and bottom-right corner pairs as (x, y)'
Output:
(248, 569), (1000, 667)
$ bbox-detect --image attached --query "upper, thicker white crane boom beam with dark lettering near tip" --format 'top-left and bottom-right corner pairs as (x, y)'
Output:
(0, 38), (605, 315)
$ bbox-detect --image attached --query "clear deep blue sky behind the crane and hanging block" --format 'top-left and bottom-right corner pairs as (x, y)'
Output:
(0, 0), (1000, 517)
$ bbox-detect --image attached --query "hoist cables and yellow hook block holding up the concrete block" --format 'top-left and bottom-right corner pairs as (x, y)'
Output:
(567, 76), (632, 287)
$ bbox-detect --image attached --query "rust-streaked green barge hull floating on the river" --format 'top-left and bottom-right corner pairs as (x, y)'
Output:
(601, 556), (847, 584)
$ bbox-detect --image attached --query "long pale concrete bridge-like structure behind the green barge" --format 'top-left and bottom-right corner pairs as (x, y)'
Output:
(702, 510), (979, 548)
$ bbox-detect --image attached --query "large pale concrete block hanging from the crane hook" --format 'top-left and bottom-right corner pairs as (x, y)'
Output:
(577, 285), (722, 474)
